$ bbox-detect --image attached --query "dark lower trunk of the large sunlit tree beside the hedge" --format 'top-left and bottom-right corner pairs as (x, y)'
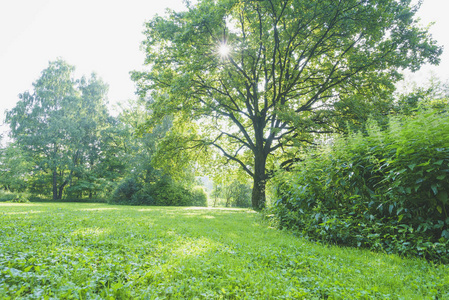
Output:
(251, 153), (267, 210)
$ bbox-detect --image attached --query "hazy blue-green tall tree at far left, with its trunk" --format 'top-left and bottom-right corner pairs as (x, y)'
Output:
(7, 59), (107, 200)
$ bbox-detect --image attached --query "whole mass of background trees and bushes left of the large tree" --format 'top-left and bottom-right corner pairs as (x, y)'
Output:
(0, 59), (207, 205)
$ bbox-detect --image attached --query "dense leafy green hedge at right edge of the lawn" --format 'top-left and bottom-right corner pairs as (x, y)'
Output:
(271, 111), (449, 263)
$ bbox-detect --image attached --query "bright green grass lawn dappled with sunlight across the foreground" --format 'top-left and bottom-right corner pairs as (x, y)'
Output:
(0, 203), (449, 299)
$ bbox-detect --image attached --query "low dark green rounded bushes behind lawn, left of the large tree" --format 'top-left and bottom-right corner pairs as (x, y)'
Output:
(109, 176), (207, 206)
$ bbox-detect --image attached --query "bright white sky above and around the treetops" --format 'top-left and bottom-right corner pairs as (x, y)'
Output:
(0, 0), (449, 138)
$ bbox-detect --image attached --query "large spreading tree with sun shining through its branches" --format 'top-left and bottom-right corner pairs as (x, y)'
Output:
(133, 0), (441, 209)
